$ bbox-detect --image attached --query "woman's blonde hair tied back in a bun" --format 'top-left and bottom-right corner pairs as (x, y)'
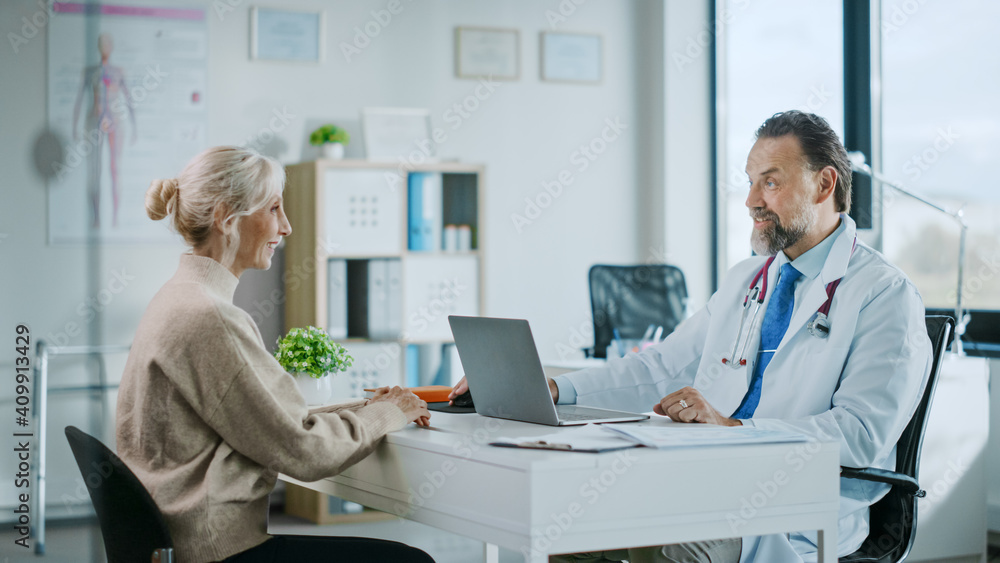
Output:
(146, 146), (285, 267)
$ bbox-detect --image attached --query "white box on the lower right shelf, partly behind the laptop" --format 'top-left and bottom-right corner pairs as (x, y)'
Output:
(403, 254), (479, 342)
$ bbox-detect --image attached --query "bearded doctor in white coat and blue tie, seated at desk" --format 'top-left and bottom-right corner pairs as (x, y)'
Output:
(457, 111), (931, 563)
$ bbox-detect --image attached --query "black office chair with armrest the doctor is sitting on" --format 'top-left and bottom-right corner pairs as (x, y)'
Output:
(840, 316), (955, 563)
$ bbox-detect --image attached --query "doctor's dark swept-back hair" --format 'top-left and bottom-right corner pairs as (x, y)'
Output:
(756, 110), (851, 213)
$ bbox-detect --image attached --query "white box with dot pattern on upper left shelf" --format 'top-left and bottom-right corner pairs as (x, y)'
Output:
(322, 169), (405, 255)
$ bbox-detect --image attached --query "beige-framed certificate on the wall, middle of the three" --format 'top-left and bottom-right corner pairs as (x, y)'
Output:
(455, 27), (521, 80)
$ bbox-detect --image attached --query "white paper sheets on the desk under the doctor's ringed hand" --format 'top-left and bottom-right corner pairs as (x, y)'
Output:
(601, 424), (808, 448)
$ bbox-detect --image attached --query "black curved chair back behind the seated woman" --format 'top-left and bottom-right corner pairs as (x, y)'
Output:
(66, 426), (174, 563)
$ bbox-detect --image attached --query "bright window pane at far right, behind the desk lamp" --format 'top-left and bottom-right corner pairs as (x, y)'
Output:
(881, 0), (1000, 309)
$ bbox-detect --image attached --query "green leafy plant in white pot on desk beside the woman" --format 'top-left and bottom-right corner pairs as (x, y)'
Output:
(274, 326), (354, 405)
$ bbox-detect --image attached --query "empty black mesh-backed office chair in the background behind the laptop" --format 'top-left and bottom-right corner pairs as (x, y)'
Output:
(584, 264), (688, 358)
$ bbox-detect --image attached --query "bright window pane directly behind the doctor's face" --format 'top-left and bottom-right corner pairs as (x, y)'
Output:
(717, 0), (844, 276)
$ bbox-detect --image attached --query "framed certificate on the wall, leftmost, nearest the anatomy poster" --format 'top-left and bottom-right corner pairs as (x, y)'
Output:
(250, 6), (325, 63)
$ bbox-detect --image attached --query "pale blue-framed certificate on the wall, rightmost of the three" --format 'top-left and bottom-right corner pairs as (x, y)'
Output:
(541, 31), (603, 83)
